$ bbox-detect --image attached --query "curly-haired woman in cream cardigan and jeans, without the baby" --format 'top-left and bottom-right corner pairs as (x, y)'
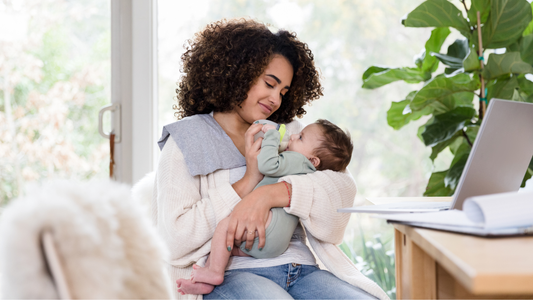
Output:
(153, 20), (388, 299)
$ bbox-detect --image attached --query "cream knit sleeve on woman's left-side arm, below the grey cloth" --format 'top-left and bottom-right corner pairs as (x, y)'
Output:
(154, 137), (240, 266)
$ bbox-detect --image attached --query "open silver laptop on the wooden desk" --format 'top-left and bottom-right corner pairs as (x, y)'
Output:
(337, 99), (533, 213)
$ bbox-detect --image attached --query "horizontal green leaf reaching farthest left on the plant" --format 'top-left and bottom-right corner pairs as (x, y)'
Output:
(363, 67), (431, 89)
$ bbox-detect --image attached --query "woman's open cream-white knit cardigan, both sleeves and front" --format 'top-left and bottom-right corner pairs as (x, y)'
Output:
(152, 121), (389, 299)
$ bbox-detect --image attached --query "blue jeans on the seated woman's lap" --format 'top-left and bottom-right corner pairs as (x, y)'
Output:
(204, 264), (376, 299)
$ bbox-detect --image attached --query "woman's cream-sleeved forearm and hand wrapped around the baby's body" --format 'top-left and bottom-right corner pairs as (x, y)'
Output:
(227, 170), (357, 248)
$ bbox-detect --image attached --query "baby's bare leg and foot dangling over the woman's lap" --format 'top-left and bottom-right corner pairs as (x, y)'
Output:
(191, 218), (231, 285)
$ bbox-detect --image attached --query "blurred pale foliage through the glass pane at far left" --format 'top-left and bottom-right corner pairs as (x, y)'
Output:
(0, 0), (111, 206)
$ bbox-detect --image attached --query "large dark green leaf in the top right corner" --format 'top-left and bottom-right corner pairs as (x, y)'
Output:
(481, 0), (533, 49)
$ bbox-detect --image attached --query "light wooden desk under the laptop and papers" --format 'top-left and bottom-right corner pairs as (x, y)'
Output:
(394, 224), (533, 299)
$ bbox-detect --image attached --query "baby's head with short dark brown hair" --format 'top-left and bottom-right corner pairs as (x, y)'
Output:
(285, 120), (353, 171)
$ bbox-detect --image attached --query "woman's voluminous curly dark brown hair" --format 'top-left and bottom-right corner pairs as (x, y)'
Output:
(173, 19), (322, 123)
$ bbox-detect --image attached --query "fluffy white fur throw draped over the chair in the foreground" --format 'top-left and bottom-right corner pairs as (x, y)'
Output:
(0, 180), (172, 299)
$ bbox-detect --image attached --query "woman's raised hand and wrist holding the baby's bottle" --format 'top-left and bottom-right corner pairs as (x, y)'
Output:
(233, 124), (264, 198)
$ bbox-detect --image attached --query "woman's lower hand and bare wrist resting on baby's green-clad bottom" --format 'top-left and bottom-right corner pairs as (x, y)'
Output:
(226, 182), (292, 250)
